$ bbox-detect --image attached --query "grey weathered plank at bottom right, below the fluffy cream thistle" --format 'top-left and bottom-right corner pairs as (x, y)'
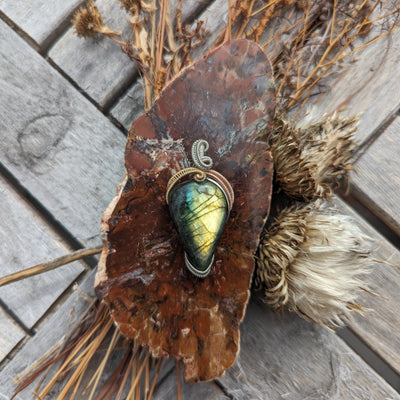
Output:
(219, 302), (400, 400)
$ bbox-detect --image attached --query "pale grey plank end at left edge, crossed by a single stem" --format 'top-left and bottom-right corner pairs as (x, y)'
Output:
(0, 177), (84, 328)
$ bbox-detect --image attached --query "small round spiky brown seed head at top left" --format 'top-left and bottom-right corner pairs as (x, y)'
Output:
(72, 0), (104, 38)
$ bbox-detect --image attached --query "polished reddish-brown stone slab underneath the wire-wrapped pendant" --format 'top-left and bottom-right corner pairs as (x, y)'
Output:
(96, 40), (275, 381)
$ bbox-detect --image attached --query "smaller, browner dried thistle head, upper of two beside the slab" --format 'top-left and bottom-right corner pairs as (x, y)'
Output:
(271, 114), (358, 201)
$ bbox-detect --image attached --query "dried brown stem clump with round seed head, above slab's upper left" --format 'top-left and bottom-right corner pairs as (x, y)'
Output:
(72, 0), (206, 109)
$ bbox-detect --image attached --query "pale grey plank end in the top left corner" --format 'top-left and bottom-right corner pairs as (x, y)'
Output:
(0, 0), (82, 48)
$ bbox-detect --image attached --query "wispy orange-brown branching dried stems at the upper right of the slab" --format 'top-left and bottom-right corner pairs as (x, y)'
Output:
(217, 0), (400, 112)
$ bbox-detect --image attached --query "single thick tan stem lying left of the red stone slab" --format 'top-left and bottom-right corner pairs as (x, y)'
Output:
(0, 247), (103, 287)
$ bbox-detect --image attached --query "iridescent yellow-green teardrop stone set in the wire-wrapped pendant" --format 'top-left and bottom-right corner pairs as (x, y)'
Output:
(169, 178), (229, 277)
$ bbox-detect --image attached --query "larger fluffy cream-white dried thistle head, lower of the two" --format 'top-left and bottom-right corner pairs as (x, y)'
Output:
(255, 203), (371, 327)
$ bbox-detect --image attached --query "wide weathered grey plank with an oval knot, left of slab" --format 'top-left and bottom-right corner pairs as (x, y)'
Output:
(0, 18), (126, 242)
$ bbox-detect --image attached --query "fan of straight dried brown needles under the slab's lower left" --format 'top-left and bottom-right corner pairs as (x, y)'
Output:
(12, 300), (162, 400)
